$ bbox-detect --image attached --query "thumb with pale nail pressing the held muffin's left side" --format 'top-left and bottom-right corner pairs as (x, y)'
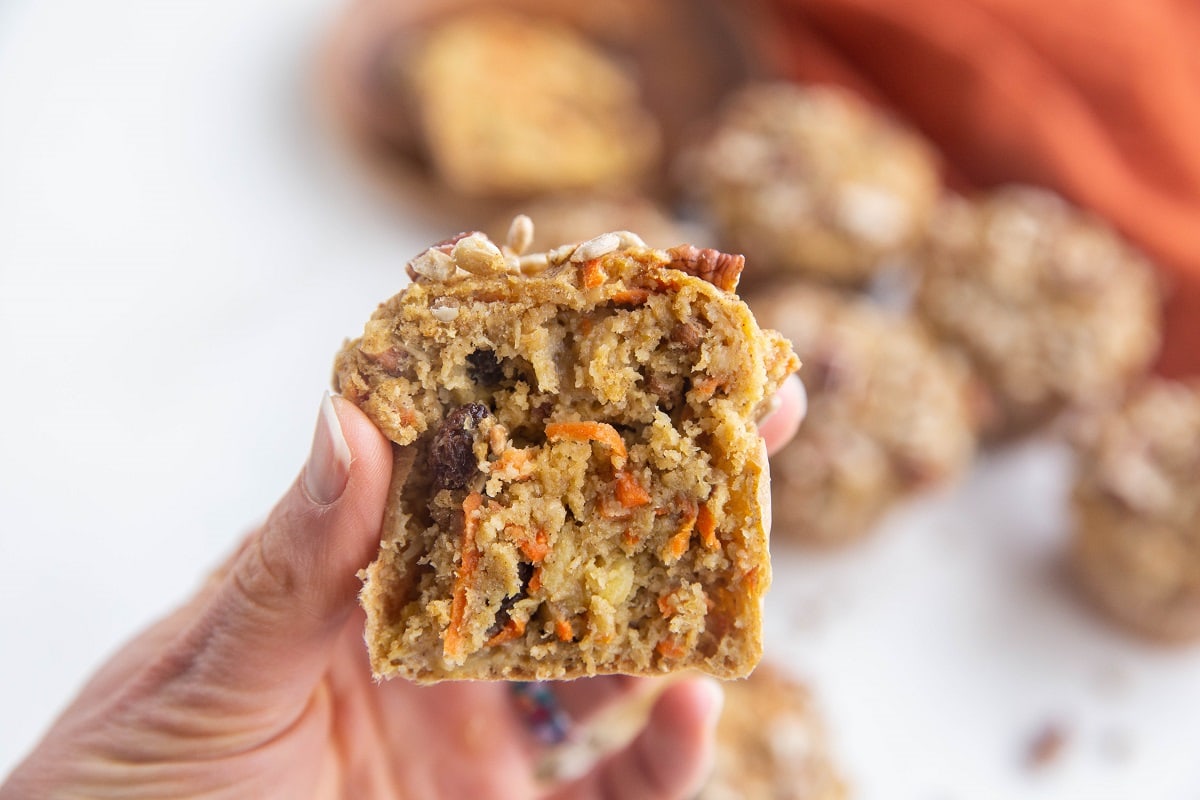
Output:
(140, 395), (391, 710)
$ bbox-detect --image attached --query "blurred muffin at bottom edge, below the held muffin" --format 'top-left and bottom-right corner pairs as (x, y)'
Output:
(697, 664), (847, 800)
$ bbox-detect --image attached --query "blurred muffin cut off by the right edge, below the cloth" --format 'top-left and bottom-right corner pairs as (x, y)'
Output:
(1070, 380), (1200, 640)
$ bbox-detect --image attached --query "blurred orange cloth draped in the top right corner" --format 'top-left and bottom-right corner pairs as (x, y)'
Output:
(762, 0), (1200, 375)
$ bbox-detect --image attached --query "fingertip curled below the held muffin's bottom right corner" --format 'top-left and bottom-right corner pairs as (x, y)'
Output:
(551, 678), (722, 800)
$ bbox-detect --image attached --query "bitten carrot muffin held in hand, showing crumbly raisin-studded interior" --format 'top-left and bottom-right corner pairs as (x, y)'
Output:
(335, 231), (797, 681)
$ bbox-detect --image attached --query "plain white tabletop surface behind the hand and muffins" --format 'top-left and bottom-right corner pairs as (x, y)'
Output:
(0, 0), (1200, 800)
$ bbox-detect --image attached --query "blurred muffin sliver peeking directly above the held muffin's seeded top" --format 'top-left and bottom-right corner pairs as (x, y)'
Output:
(485, 194), (712, 252)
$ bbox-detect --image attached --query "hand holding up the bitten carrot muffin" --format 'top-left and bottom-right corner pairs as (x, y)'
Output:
(0, 378), (803, 800)
